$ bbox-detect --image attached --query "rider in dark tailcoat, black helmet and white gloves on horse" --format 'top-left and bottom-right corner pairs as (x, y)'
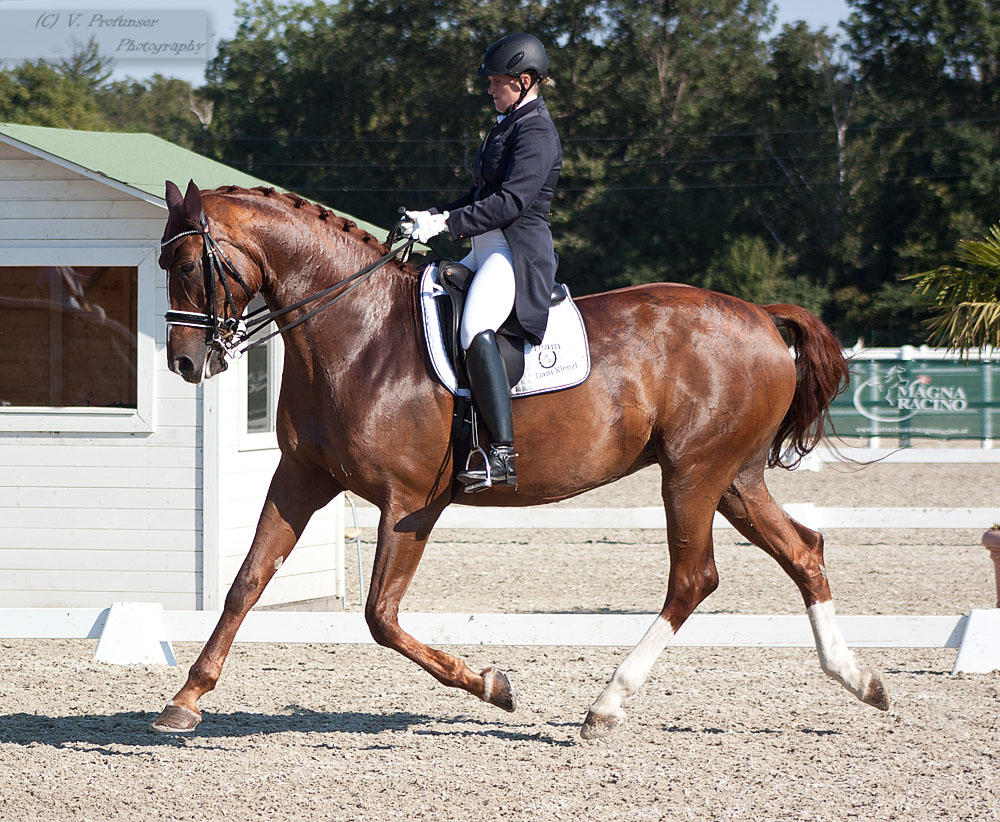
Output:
(406, 34), (562, 492)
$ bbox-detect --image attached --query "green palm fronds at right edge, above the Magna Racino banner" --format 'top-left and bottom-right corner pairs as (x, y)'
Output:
(906, 224), (1000, 354)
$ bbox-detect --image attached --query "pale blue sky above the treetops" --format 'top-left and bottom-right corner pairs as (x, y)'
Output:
(0, 0), (848, 85)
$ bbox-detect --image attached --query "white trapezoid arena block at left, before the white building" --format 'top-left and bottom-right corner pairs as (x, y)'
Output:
(94, 602), (177, 666)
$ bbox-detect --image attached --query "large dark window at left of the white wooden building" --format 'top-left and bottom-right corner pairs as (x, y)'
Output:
(0, 265), (139, 409)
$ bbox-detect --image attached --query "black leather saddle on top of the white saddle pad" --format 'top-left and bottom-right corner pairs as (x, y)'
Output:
(438, 260), (569, 388)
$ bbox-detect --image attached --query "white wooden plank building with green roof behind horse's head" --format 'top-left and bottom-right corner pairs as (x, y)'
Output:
(0, 124), (384, 609)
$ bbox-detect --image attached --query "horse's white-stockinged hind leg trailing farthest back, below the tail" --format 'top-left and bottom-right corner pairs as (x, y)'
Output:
(719, 460), (889, 711)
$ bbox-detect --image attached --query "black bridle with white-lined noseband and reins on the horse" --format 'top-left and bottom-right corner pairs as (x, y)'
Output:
(160, 212), (415, 359)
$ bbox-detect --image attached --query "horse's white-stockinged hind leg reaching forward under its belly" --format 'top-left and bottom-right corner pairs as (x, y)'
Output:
(580, 472), (720, 739)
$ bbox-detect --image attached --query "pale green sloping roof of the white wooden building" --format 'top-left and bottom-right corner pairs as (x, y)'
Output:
(0, 123), (386, 240)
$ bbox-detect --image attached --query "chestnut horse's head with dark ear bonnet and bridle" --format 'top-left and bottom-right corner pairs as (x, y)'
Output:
(159, 180), (261, 384)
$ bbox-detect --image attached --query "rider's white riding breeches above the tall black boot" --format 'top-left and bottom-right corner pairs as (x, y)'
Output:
(461, 229), (514, 350)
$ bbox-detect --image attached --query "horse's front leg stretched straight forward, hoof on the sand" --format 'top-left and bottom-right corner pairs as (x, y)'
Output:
(152, 457), (342, 733)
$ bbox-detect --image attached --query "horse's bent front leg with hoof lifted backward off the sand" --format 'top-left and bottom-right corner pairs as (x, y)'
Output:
(365, 500), (515, 711)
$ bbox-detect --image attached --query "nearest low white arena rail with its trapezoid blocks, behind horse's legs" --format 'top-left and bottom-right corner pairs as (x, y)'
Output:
(0, 602), (1000, 673)
